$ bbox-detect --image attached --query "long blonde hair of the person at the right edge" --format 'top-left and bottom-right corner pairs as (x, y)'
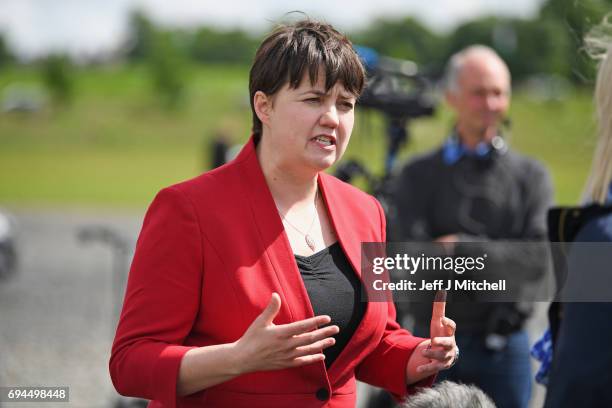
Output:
(585, 14), (612, 204)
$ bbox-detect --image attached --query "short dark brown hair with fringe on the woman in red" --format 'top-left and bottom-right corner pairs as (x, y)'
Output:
(249, 19), (365, 141)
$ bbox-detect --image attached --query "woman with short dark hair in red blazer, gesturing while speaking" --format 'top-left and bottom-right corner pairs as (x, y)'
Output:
(110, 20), (456, 407)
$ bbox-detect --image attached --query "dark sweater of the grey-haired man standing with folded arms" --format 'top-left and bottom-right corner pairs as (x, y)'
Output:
(389, 149), (552, 334)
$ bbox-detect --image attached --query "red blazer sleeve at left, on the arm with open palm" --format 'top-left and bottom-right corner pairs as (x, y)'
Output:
(109, 187), (203, 407)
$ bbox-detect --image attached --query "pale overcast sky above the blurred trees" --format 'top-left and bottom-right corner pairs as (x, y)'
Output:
(0, 0), (543, 56)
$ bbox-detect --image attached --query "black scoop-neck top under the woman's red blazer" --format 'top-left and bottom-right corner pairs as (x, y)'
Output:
(295, 242), (366, 368)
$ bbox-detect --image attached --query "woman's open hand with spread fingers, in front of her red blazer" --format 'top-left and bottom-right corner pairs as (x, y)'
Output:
(234, 293), (340, 374)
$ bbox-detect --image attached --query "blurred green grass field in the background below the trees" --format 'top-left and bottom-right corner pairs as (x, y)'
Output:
(0, 66), (595, 208)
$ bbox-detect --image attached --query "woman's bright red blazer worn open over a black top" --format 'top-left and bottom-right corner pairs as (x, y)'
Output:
(110, 139), (432, 408)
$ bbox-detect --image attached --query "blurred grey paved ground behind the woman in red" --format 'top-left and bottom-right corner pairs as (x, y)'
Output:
(0, 211), (545, 408)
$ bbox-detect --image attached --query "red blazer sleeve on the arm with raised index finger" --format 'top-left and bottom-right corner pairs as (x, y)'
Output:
(355, 200), (436, 400)
